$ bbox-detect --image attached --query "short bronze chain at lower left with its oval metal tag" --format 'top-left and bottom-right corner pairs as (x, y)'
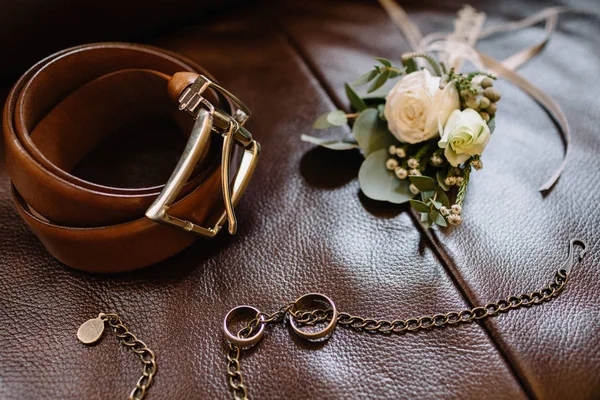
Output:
(77, 313), (157, 400)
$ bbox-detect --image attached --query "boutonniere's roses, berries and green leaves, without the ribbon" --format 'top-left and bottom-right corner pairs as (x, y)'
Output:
(302, 53), (501, 226)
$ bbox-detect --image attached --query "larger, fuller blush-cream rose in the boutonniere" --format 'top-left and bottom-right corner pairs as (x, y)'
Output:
(384, 69), (460, 144)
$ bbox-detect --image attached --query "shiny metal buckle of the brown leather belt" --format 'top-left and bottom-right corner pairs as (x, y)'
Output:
(146, 75), (260, 237)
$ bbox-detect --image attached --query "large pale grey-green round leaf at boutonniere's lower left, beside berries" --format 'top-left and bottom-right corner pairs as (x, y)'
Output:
(358, 149), (414, 204)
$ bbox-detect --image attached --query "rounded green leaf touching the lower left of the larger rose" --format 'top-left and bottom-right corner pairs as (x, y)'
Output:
(352, 108), (397, 156)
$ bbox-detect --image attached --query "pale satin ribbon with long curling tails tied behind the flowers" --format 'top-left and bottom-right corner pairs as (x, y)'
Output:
(379, 0), (592, 192)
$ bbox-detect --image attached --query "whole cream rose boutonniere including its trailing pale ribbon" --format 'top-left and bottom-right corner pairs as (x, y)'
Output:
(302, 0), (569, 227)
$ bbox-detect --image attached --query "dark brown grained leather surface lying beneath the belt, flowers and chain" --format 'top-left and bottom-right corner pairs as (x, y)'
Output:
(0, 0), (600, 399)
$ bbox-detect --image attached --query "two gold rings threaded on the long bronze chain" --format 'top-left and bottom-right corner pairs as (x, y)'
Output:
(223, 293), (338, 347)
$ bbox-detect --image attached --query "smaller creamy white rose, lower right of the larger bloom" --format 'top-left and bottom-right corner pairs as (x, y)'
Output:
(438, 108), (490, 167)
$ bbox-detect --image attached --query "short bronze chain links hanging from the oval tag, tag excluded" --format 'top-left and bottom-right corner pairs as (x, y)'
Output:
(100, 314), (157, 400)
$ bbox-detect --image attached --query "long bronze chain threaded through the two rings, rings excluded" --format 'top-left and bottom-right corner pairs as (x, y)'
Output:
(227, 268), (568, 400)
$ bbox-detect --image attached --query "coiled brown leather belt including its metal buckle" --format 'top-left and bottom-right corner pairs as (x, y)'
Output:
(3, 43), (259, 272)
